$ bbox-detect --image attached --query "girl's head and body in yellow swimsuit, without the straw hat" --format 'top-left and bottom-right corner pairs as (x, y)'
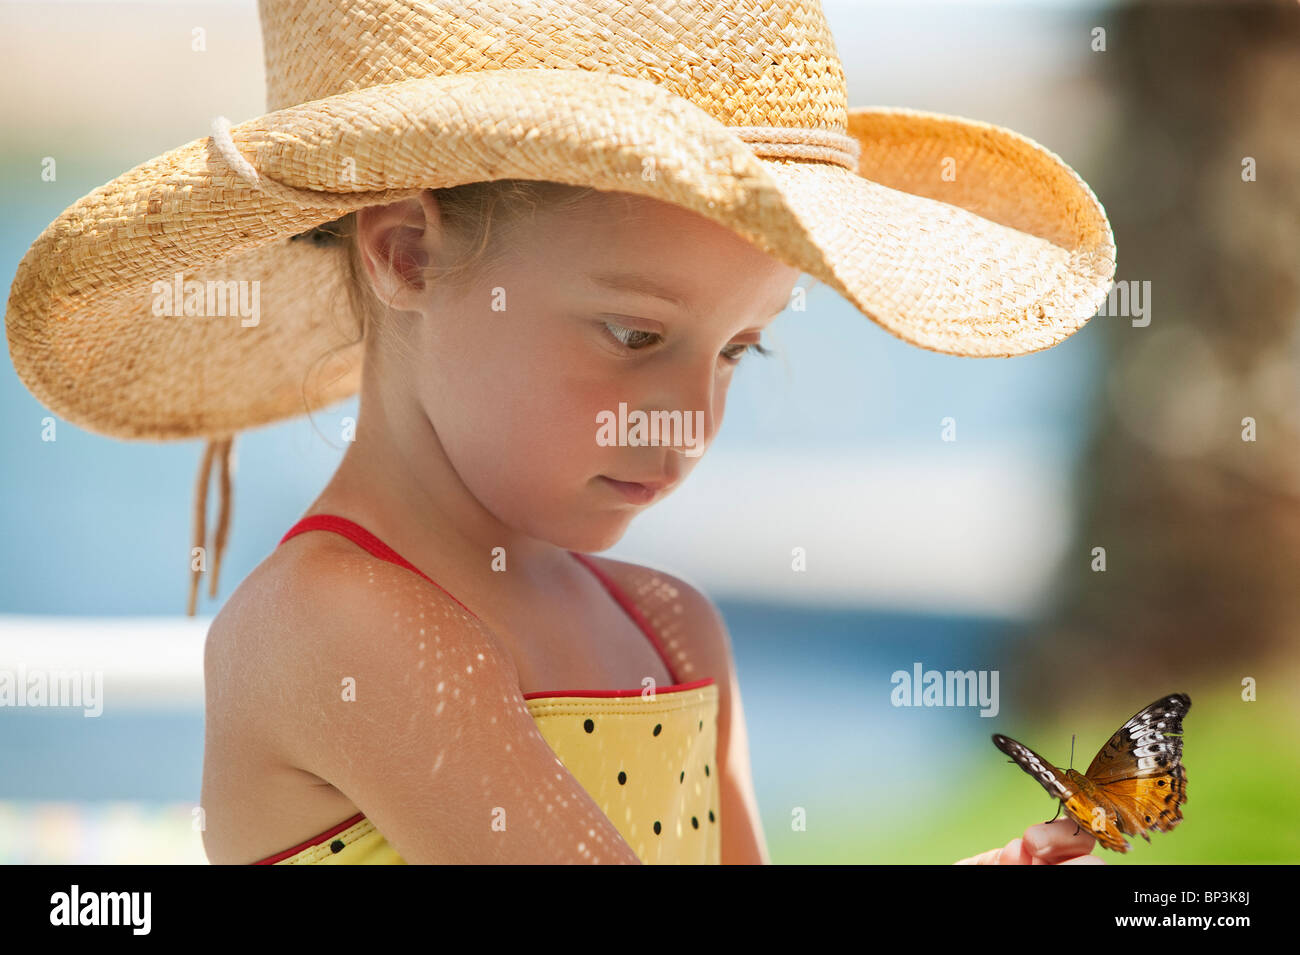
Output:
(203, 183), (774, 863)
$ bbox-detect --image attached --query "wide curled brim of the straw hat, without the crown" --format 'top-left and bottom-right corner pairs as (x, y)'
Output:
(5, 69), (1115, 439)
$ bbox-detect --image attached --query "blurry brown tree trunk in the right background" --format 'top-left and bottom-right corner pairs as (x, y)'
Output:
(1015, 0), (1300, 709)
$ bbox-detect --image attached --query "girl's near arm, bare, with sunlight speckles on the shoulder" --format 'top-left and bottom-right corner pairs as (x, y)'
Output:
(263, 559), (640, 864)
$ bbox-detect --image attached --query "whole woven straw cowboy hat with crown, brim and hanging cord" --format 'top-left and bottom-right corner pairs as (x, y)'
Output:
(5, 0), (1115, 615)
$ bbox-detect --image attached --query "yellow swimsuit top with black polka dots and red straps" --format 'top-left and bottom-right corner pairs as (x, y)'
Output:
(255, 515), (722, 865)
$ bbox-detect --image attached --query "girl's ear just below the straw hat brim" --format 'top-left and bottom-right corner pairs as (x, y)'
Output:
(356, 190), (442, 312)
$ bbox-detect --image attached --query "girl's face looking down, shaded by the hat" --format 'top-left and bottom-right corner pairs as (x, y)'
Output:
(366, 192), (800, 551)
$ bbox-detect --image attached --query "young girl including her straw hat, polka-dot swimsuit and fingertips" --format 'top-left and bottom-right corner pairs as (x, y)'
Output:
(9, 0), (1114, 864)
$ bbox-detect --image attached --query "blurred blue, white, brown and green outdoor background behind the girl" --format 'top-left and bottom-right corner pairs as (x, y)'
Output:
(0, 0), (1300, 864)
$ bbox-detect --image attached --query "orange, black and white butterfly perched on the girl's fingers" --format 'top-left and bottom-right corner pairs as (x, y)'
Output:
(993, 693), (1192, 852)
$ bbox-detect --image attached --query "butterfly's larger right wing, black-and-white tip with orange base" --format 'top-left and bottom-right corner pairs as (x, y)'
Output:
(1084, 693), (1192, 842)
